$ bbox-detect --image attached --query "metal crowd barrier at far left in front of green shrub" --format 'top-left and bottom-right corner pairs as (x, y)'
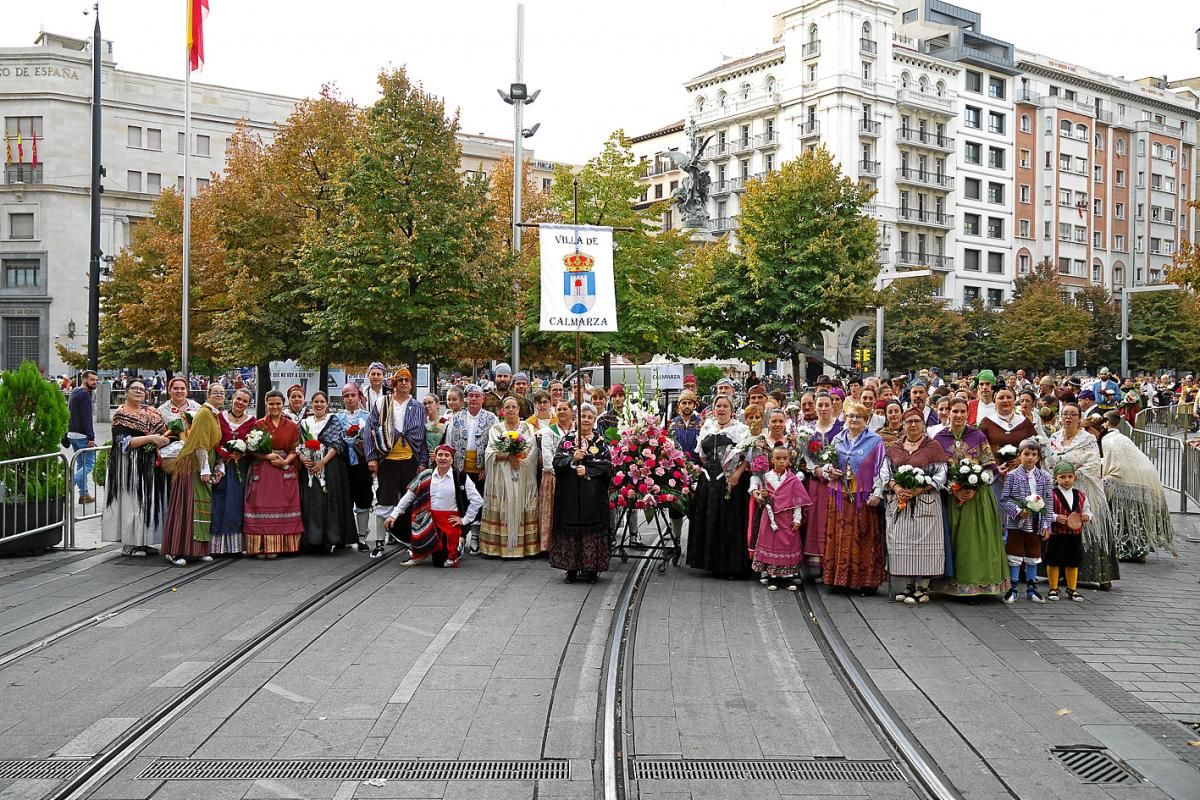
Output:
(0, 452), (71, 552)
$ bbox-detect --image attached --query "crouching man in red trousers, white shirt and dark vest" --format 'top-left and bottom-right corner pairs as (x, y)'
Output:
(383, 445), (484, 567)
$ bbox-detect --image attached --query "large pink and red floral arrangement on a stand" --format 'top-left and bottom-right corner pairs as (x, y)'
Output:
(608, 416), (700, 519)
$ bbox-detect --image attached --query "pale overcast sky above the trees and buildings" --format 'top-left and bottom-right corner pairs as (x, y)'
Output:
(9, 0), (1200, 162)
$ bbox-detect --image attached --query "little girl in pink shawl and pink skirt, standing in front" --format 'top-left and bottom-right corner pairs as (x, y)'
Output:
(750, 447), (812, 591)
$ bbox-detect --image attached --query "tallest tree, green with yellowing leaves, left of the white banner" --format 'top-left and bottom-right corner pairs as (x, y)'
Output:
(301, 68), (512, 368)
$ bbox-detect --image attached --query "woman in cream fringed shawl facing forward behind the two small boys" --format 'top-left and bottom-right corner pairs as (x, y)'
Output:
(1043, 403), (1121, 591)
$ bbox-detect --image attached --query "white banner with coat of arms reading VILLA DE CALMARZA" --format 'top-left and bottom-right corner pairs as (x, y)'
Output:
(538, 224), (617, 332)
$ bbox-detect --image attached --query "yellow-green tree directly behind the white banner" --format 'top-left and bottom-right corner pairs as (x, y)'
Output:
(522, 131), (696, 363)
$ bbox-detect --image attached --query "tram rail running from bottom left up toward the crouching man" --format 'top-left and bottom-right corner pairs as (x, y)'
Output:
(36, 551), (397, 800)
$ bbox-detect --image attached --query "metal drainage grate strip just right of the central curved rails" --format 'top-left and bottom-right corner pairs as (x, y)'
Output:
(634, 758), (905, 783)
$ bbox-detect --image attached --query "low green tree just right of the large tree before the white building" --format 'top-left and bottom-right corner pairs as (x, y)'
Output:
(866, 277), (967, 374)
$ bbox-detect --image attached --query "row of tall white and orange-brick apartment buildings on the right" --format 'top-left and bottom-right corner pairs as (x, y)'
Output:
(647, 0), (1200, 363)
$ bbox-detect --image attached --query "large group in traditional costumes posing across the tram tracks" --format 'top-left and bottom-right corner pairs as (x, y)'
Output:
(96, 362), (1180, 604)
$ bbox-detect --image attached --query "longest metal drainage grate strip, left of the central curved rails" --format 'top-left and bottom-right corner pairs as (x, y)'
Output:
(138, 758), (571, 781)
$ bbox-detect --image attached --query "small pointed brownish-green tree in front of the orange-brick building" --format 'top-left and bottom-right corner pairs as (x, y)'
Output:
(996, 259), (1091, 369)
